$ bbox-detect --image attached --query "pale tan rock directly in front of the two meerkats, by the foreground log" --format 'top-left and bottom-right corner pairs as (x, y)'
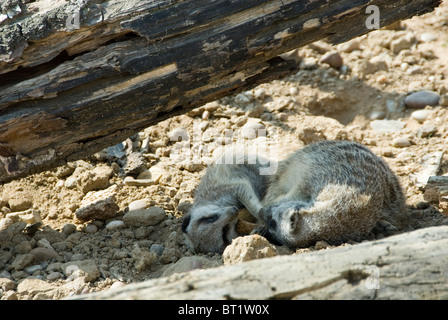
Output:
(222, 234), (277, 265)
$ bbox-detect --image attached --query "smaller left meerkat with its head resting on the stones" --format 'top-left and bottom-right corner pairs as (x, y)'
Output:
(182, 154), (267, 253)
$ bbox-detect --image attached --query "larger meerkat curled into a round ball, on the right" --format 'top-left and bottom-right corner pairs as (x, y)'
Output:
(258, 141), (405, 249)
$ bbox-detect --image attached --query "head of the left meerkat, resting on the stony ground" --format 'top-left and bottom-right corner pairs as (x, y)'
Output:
(182, 205), (238, 253)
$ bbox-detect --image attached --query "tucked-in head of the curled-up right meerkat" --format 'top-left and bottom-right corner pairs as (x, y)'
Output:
(258, 201), (309, 247)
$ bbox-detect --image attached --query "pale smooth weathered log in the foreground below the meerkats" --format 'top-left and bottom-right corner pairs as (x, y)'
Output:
(71, 226), (448, 300)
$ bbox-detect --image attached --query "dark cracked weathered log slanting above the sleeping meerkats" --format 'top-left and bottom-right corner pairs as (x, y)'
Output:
(0, 0), (440, 183)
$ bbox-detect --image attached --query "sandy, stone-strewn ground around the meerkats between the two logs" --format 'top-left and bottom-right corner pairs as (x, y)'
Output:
(0, 1), (448, 300)
